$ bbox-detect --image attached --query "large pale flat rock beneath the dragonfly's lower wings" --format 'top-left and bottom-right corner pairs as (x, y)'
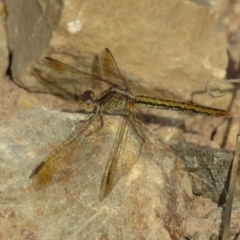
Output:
(0, 106), (239, 239)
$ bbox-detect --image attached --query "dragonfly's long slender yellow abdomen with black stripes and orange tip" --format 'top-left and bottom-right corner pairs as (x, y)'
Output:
(134, 96), (230, 117)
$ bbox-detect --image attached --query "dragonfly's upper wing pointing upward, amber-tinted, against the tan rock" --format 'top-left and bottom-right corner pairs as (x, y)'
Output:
(101, 48), (129, 89)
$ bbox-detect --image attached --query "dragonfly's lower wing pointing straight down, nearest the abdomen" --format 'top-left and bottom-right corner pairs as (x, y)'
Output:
(99, 107), (144, 199)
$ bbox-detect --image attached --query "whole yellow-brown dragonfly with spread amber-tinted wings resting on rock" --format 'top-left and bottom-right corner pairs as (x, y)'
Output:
(31, 48), (230, 199)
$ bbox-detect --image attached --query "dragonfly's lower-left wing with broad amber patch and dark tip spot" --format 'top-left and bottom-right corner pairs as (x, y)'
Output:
(32, 113), (104, 189)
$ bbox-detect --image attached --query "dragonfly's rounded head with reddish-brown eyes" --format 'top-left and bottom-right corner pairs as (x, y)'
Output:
(78, 90), (96, 112)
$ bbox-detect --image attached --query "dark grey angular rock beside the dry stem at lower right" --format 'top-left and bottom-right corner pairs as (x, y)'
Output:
(171, 142), (240, 206)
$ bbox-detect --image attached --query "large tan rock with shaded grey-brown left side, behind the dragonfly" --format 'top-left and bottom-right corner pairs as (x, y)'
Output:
(6, 0), (231, 108)
